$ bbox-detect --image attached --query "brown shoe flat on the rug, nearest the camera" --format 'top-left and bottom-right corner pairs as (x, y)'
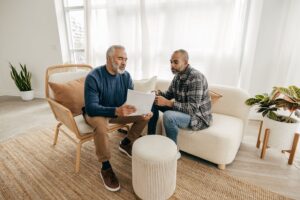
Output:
(100, 168), (120, 192)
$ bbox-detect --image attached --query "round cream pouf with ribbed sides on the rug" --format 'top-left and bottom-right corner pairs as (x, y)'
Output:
(132, 135), (177, 200)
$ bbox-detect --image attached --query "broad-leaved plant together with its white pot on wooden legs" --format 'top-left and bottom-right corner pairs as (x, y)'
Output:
(245, 86), (300, 152)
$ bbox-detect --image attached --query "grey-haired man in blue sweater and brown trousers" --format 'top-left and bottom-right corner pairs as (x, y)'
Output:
(83, 45), (152, 191)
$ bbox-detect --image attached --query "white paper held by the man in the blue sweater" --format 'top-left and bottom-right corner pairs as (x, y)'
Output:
(126, 90), (155, 116)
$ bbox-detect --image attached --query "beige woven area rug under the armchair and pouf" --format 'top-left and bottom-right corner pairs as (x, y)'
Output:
(0, 128), (288, 200)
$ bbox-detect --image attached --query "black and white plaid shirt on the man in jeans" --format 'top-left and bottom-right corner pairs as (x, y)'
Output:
(160, 66), (212, 130)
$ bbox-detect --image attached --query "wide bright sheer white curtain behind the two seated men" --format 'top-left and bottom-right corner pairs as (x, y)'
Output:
(87, 0), (249, 86)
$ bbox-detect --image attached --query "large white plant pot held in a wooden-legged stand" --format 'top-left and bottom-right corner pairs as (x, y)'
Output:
(261, 117), (300, 150)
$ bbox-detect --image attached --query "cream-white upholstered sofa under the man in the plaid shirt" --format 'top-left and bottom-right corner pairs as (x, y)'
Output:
(156, 80), (249, 169)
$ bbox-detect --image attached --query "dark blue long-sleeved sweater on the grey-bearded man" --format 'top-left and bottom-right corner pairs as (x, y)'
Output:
(83, 65), (133, 117)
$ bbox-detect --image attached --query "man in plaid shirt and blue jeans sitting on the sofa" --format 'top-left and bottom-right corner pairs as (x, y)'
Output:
(148, 49), (212, 157)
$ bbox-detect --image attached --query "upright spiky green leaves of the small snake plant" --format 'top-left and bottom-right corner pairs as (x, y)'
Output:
(9, 63), (32, 91)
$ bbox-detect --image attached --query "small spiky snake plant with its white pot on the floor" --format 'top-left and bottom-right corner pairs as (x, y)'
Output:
(9, 63), (34, 101)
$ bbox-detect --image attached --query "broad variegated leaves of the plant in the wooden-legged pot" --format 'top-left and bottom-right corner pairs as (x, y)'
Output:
(245, 86), (300, 123)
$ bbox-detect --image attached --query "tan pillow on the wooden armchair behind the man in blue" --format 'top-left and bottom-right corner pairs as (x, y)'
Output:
(49, 77), (85, 116)
